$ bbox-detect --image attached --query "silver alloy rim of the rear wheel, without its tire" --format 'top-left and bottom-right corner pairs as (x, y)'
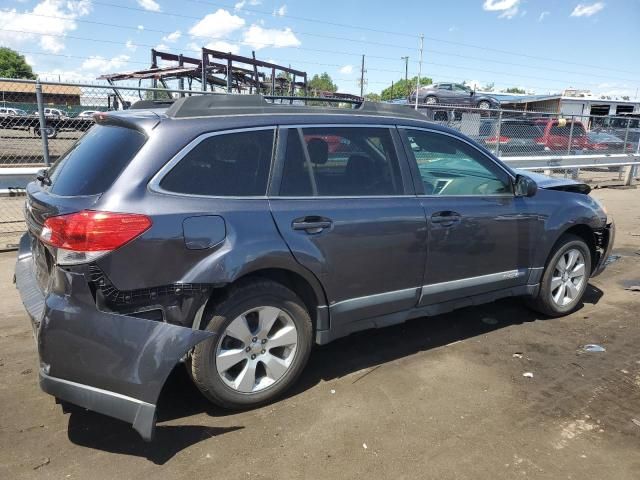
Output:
(215, 306), (298, 393)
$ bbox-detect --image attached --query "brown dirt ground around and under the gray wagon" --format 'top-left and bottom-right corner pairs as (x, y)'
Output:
(0, 189), (640, 480)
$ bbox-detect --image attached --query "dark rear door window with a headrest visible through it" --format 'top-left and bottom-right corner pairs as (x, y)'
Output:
(280, 127), (403, 196)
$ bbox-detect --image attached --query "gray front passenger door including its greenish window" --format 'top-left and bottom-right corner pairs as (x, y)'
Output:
(401, 129), (536, 305)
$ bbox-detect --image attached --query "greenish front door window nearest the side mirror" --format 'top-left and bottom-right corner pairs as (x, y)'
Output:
(404, 130), (511, 195)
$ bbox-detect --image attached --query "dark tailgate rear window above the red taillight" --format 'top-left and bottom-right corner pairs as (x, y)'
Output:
(49, 125), (146, 196)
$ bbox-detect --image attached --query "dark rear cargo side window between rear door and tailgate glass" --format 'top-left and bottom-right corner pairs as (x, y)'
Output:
(160, 129), (274, 197)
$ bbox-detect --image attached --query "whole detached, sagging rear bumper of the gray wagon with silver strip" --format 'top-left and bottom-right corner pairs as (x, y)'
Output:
(16, 234), (213, 440)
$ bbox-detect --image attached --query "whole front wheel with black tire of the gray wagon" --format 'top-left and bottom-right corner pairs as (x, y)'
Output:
(527, 234), (591, 317)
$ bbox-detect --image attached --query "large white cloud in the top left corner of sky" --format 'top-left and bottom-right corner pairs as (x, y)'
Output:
(0, 0), (91, 53)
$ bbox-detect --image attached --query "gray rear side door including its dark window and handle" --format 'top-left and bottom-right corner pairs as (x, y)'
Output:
(270, 125), (426, 329)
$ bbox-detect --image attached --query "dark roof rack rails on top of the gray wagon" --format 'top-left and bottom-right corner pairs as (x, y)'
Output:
(165, 94), (425, 120)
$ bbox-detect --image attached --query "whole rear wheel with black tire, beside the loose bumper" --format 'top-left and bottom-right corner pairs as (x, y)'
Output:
(191, 280), (313, 409)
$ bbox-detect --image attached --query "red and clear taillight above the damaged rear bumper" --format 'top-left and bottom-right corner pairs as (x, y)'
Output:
(40, 210), (151, 265)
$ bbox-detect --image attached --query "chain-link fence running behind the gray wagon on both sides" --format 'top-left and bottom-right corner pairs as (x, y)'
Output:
(0, 79), (640, 250)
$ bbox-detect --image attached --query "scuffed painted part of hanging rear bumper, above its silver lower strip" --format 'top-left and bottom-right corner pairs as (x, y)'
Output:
(38, 268), (214, 404)
